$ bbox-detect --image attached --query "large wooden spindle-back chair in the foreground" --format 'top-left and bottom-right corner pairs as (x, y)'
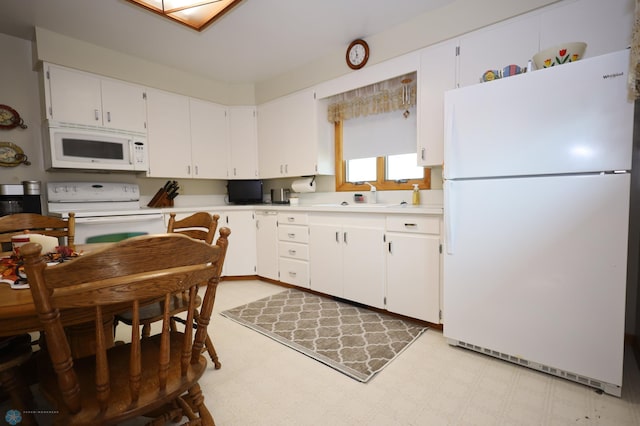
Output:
(21, 228), (230, 425)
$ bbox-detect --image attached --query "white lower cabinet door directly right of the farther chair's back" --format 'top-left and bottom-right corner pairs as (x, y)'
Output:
(218, 210), (256, 276)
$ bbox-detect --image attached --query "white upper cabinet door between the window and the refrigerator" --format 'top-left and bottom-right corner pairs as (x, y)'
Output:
(417, 41), (458, 166)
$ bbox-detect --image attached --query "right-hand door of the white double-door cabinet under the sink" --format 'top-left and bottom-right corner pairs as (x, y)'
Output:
(342, 226), (385, 309)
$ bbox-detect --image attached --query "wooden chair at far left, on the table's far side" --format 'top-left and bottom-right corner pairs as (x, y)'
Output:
(0, 213), (76, 250)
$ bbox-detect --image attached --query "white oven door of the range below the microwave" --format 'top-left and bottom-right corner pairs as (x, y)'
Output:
(75, 213), (167, 244)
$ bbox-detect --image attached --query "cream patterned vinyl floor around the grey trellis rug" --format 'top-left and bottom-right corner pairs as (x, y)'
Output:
(5, 280), (640, 426)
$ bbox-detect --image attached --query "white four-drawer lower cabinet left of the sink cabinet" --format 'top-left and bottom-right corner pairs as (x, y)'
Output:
(278, 213), (309, 288)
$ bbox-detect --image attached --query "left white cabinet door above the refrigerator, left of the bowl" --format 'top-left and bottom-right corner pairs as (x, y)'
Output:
(458, 15), (540, 88)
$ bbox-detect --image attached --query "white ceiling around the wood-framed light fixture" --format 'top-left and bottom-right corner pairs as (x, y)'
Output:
(0, 0), (454, 83)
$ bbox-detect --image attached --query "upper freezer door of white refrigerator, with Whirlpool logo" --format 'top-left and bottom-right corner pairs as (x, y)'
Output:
(444, 51), (633, 179)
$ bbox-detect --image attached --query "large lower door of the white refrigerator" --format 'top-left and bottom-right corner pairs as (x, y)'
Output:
(443, 174), (630, 386)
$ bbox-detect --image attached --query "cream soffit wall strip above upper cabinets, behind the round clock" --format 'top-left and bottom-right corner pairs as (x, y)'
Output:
(30, 0), (558, 105)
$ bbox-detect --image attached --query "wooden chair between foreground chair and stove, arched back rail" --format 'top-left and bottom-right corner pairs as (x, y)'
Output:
(115, 212), (222, 370)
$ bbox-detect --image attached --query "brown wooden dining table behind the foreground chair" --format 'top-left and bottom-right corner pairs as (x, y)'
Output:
(0, 243), (119, 356)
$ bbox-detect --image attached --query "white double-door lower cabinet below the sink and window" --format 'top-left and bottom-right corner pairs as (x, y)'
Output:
(309, 214), (385, 308)
